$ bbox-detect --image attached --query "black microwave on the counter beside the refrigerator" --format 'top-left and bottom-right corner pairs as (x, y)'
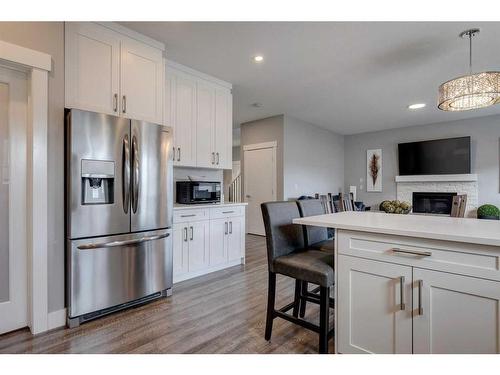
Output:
(176, 181), (220, 204)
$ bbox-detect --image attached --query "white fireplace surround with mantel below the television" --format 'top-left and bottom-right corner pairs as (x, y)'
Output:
(396, 174), (478, 217)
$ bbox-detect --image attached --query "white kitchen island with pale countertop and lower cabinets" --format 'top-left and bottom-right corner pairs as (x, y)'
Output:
(294, 212), (500, 353)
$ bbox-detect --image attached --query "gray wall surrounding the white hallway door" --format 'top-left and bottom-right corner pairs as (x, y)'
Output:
(241, 115), (284, 200)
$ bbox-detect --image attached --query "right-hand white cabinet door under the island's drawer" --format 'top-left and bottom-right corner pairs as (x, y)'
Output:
(413, 268), (500, 354)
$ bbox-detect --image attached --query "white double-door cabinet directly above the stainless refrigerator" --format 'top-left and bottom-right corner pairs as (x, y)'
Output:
(65, 22), (164, 123)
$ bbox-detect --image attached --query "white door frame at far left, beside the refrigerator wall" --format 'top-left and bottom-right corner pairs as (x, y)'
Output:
(0, 40), (52, 334)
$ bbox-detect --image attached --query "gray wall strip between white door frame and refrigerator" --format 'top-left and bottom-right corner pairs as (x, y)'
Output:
(0, 22), (64, 311)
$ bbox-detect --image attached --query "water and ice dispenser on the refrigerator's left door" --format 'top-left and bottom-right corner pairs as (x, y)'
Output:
(82, 159), (115, 205)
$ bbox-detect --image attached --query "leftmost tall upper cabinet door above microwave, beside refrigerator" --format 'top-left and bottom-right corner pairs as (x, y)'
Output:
(171, 70), (196, 167)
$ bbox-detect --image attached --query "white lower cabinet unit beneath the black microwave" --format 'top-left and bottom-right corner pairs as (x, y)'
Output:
(173, 204), (245, 283)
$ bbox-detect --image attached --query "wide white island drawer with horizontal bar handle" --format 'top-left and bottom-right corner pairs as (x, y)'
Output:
(337, 230), (500, 280)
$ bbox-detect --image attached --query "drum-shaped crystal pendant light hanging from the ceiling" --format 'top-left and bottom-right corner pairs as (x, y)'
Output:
(438, 29), (500, 111)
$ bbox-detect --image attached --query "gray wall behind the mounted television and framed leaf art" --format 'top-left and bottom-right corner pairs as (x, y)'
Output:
(344, 114), (500, 206)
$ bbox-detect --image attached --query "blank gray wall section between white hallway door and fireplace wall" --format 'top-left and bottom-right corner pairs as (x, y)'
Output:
(283, 115), (344, 199)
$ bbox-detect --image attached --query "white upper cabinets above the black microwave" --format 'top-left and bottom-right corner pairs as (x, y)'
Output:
(164, 61), (232, 169)
